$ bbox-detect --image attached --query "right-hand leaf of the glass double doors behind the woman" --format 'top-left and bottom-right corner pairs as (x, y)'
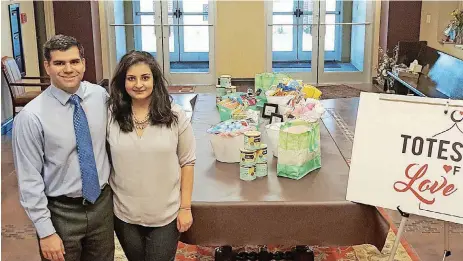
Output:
(161, 0), (216, 85)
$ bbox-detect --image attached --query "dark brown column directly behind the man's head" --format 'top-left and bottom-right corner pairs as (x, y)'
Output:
(53, 1), (103, 83)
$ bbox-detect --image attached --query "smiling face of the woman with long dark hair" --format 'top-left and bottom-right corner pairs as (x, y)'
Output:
(125, 63), (154, 101)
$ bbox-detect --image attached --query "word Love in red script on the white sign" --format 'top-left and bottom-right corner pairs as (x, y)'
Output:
(394, 164), (457, 205)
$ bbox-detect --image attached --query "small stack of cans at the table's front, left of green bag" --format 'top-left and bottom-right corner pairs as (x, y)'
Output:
(240, 131), (268, 180)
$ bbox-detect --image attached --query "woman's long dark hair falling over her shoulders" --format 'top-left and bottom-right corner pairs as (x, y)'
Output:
(108, 51), (178, 132)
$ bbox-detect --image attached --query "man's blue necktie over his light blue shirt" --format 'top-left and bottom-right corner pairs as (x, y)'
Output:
(69, 94), (101, 204)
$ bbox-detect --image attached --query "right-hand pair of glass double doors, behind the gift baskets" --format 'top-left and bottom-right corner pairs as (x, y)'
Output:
(267, 0), (374, 84)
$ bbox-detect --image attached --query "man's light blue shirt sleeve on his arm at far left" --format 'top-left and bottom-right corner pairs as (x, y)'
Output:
(12, 110), (56, 238)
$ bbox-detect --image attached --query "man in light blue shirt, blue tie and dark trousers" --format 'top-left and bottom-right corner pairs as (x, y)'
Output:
(13, 35), (114, 261)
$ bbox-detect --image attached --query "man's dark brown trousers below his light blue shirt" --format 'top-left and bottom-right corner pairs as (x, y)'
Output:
(40, 185), (114, 261)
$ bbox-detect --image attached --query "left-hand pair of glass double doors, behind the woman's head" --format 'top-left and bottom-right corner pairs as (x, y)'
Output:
(104, 0), (215, 85)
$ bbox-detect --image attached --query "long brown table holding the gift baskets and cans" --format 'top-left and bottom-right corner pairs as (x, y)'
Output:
(170, 94), (389, 250)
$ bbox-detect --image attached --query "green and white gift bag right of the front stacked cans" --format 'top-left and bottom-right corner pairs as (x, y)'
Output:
(277, 120), (322, 180)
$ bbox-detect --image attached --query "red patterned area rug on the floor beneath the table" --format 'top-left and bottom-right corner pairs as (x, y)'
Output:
(114, 230), (418, 261)
